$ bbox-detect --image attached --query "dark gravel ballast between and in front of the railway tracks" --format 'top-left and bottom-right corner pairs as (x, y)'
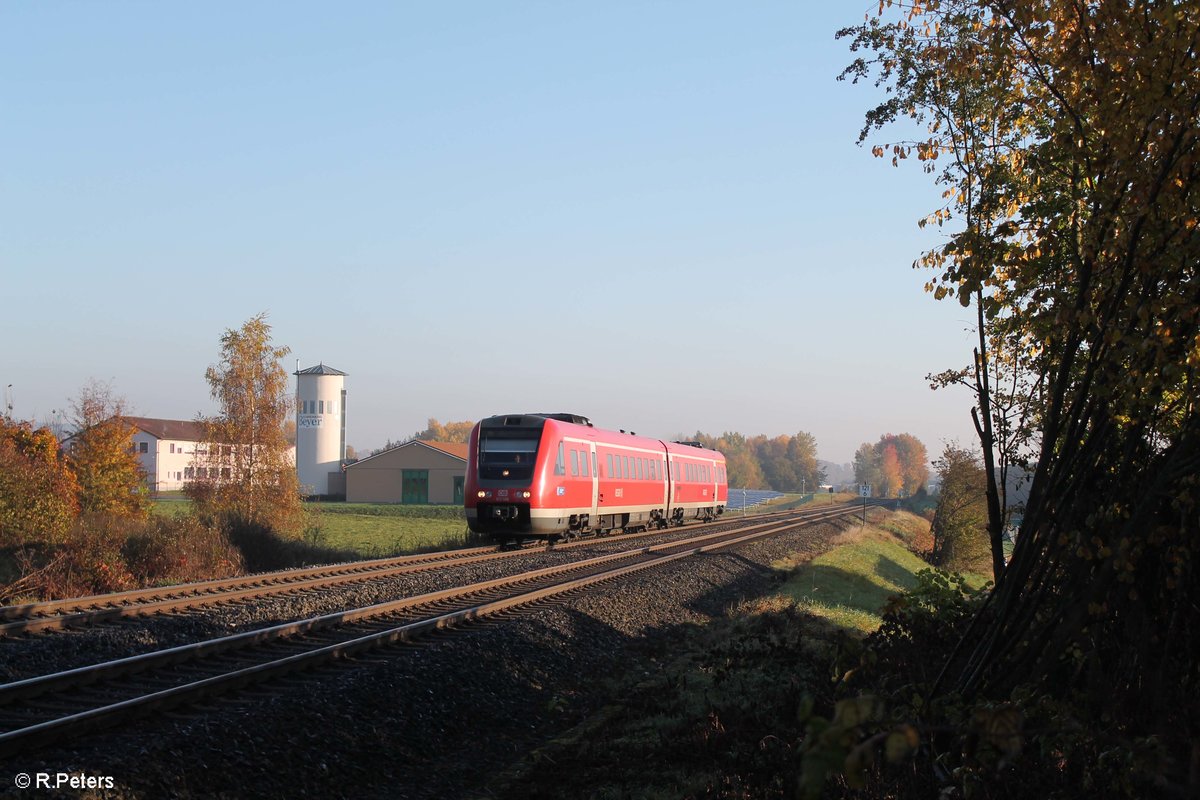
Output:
(0, 521), (854, 798)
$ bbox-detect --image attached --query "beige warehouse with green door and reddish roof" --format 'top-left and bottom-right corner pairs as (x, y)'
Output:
(346, 439), (467, 505)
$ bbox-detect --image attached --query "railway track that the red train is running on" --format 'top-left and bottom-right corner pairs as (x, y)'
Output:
(0, 503), (849, 637)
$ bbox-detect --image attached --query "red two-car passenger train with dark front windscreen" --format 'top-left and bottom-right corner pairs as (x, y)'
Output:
(466, 414), (728, 540)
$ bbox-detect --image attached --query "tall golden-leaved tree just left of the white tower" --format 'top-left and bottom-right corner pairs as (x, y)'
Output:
(185, 313), (304, 534)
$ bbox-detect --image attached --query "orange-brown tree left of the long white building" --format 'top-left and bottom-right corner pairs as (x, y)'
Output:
(67, 380), (150, 519)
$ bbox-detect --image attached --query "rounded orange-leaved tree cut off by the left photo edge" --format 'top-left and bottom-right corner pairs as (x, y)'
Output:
(0, 416), (79, 547)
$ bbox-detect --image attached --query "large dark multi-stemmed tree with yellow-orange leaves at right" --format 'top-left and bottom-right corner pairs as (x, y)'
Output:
(844, 0), (1200, 792)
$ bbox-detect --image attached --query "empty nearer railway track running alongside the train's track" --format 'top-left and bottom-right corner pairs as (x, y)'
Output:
(0, 506), (857, 754)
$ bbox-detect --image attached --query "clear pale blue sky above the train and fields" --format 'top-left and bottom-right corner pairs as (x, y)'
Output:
(0, 1), (971, 462)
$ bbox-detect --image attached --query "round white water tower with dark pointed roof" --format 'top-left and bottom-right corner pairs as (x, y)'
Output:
(295, 363), (346, 495)
